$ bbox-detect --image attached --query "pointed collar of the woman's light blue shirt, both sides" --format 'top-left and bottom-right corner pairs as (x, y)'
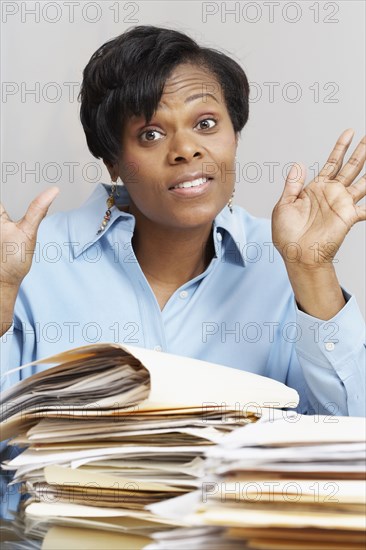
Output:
(68, 183), (246, 267)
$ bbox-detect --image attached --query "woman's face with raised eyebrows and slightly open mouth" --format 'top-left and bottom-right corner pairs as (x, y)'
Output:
(110, 64), (237, 230)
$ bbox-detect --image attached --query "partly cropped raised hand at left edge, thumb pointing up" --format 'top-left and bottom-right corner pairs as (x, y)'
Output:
(0, 187), (60, 292)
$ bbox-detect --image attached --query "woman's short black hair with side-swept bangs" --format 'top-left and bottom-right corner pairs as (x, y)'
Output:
(79, 25), (249, 166)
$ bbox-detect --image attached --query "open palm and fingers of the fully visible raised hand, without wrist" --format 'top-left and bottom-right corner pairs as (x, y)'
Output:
(272, 130), (366, 270)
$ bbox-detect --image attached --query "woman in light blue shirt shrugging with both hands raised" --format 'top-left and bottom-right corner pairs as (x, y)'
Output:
(0, 26), (366, 422)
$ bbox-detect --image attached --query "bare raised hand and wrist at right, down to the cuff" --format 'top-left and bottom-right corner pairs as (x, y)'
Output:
(272, 130), (366, 320)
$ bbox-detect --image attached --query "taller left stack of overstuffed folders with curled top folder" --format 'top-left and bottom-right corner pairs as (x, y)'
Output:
(0, 344), (298, 550)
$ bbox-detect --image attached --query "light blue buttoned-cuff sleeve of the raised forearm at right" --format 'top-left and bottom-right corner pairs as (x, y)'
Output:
(295, 289), (366, 416)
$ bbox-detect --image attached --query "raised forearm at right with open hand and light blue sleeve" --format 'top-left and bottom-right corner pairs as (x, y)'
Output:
(272, 130), (366, 416)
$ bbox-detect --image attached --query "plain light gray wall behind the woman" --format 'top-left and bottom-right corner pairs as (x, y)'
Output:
(1, 1), (366, 312)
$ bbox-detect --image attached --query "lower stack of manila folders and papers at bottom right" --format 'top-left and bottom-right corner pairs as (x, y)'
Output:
(147, 411), (366, 550)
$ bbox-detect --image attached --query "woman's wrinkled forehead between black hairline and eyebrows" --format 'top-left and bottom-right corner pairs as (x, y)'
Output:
(158, 64), (222, 109)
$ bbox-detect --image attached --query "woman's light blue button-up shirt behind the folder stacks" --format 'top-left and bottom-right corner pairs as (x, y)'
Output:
(1, 184), (365, 516)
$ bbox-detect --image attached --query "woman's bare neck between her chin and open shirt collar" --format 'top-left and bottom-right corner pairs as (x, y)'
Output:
(132, 211), (214, 291)
